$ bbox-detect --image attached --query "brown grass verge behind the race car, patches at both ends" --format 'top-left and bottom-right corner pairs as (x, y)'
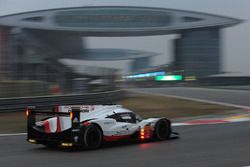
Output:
(0, 93), (235, 133)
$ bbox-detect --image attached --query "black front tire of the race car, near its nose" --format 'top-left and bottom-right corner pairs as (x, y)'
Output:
(154, 119), (171, 141)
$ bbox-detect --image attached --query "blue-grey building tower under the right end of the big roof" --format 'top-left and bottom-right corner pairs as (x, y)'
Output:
(175, 27), (221, 77)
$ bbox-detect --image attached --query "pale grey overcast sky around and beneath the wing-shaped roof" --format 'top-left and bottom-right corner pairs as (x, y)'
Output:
(0, 0), (250, 75)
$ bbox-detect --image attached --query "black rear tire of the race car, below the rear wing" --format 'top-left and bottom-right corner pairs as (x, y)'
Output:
(83, 124), (103, 150)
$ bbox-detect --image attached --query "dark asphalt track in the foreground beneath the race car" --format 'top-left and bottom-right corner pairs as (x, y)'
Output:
(0, 122), (250, 167)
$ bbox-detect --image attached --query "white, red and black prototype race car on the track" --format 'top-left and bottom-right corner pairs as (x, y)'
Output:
(26, 105), (177, 149)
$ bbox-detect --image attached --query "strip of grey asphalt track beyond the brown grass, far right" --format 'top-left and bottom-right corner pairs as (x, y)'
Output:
(130, 87), (250, 108)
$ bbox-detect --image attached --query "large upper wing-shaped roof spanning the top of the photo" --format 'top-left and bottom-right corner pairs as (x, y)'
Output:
(0, 6), (242, 36)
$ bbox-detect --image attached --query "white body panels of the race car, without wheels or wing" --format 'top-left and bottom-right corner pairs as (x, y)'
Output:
(36, 105), (161, 137)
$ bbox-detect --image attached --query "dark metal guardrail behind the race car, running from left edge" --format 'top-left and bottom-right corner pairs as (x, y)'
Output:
(0, 90), (124, 112)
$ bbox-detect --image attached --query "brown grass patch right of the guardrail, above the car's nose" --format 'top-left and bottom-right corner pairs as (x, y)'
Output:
(120, 94), (236, 119)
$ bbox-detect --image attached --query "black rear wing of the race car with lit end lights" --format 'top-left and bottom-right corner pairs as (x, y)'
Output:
(25, 106), (83, 145)
